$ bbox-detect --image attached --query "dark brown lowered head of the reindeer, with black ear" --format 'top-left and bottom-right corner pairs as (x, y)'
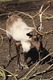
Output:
(27, 29), (43, 51)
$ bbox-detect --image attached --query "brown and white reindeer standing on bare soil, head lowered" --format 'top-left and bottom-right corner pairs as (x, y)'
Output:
(6, 14), (42, 69)
